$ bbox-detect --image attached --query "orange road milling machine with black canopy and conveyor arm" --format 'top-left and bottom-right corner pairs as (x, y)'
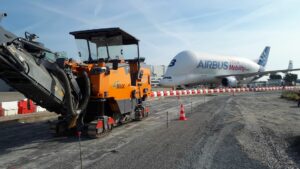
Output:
(0, 14), (151, 137)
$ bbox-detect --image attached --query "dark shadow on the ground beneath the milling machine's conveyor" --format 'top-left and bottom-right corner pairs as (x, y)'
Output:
(0, 121), (101, 156)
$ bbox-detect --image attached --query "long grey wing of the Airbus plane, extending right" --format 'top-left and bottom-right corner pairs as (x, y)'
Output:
(217, 68), (300, 78)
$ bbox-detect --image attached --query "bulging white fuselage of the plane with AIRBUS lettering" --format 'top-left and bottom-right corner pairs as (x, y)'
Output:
(160, 51), (262, 87)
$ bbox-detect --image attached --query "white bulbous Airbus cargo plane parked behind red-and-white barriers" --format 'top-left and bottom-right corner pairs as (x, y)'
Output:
(160, 46), (300, 87)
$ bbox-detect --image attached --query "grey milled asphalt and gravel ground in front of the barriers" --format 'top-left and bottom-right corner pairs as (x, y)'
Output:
(0, 92), (300, 169)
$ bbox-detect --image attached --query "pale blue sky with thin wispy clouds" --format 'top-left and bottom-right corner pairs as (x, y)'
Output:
(0, 0), (300, 73)
